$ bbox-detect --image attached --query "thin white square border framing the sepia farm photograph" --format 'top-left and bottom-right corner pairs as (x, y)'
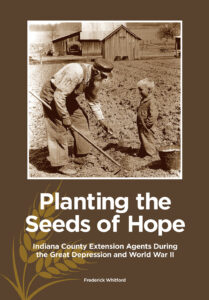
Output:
(27, 20), (183, 180)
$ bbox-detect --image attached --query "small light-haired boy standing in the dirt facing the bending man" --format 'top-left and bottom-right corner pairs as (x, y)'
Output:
(137, 78), (158, 157)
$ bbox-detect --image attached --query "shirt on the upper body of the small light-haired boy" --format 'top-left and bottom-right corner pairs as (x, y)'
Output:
(137, 95), (158, 129)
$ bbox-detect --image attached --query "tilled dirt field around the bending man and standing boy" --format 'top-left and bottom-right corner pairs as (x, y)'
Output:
(28, 58), (181, 178)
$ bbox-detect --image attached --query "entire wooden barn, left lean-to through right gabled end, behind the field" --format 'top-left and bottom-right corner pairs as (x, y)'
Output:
(53, 25), (142, 61)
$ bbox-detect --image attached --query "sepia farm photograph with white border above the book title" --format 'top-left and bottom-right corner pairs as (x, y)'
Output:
(27, 20), (183, 180)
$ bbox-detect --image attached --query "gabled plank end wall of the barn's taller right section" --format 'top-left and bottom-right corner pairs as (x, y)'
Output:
(103, 28), (141, 61)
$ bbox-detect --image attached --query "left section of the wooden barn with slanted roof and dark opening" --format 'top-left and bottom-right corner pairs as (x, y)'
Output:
(52, 31), (81, 55)
